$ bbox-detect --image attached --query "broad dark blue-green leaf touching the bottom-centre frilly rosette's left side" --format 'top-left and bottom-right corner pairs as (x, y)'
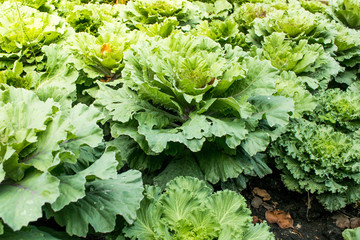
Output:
(48, 170), (143, 237)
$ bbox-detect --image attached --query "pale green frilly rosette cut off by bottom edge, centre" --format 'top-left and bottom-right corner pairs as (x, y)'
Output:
(124, 177), (274, 240)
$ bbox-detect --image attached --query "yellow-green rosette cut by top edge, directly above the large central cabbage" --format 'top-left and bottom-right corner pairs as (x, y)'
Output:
(123, 0), (200, 29)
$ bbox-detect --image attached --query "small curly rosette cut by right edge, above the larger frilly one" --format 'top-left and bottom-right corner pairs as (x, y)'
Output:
(310, 89), (360, 133)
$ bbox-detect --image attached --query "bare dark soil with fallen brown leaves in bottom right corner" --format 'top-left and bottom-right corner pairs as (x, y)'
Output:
(241, 170), (360, 240)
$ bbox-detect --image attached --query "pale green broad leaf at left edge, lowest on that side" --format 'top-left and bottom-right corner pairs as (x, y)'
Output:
(0, 171), (60, 230)
